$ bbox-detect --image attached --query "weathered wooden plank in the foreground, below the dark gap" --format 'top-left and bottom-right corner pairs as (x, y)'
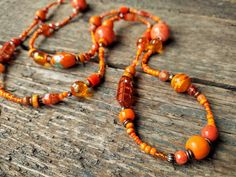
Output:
(1, 52), (236, 176)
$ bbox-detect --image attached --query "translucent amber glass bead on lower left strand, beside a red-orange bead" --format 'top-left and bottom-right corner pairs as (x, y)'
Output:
(71, 81), (89, 97)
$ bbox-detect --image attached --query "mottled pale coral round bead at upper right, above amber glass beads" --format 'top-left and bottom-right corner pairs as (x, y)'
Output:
(151, 22), (170, 42)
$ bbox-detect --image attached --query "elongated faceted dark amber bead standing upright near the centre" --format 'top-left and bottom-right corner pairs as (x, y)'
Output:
(116, 76), (134, 108)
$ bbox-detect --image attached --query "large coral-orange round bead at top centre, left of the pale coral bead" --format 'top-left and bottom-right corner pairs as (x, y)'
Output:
(95, 25), (115, 46)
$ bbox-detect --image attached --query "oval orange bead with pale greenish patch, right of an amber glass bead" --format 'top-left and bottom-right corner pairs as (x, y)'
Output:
(50, 52), (76, 68)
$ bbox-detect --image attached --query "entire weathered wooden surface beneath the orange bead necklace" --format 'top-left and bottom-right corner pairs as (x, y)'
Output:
(0, 0), (236, 177)
